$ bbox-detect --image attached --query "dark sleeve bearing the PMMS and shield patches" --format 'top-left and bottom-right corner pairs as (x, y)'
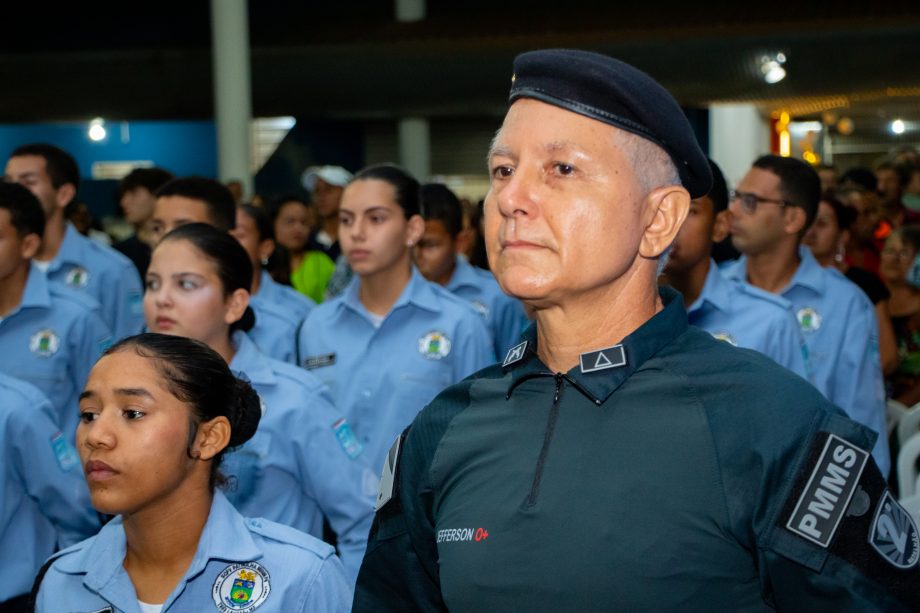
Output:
(757, 416), (920, 612)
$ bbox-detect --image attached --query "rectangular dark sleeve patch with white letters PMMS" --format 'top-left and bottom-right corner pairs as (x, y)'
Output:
(786, 434), (869, 547)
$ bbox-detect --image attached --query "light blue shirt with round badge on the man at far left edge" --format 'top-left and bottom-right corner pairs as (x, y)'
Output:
(0, 264), (112, 442)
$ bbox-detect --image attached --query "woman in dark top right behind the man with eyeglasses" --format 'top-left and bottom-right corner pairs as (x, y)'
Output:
(802, 194), (898, 375)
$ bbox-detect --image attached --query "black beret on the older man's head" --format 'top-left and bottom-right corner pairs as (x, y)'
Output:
(508, 49), (712, 198)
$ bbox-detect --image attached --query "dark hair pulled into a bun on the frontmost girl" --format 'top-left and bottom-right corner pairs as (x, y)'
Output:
(103, 332), (262, 490)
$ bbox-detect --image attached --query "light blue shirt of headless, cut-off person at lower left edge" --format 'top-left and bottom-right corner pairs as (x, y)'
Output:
(0, 374), (100, 602)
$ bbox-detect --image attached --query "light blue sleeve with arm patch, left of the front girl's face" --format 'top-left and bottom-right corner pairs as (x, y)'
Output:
(6, 392), (100, 548)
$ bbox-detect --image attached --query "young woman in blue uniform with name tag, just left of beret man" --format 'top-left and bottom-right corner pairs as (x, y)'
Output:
(298, 165), (494, 466)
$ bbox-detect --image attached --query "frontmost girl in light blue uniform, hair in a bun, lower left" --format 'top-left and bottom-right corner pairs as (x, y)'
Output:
(33, 334), (351, 613)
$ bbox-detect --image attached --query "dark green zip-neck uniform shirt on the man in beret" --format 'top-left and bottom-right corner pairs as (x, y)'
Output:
(354, 290), (920, 612)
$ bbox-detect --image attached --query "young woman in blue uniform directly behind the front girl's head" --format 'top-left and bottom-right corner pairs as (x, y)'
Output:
(144, 224), (377, 580)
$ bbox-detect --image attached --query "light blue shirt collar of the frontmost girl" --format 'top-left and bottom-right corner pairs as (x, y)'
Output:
(56, 491), (262, 610)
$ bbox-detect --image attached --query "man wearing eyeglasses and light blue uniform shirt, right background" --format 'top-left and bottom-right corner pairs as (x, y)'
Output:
(724, 155), (891, 475)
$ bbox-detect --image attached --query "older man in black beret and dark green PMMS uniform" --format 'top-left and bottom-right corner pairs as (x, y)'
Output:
(354, 50), (920, 612)
